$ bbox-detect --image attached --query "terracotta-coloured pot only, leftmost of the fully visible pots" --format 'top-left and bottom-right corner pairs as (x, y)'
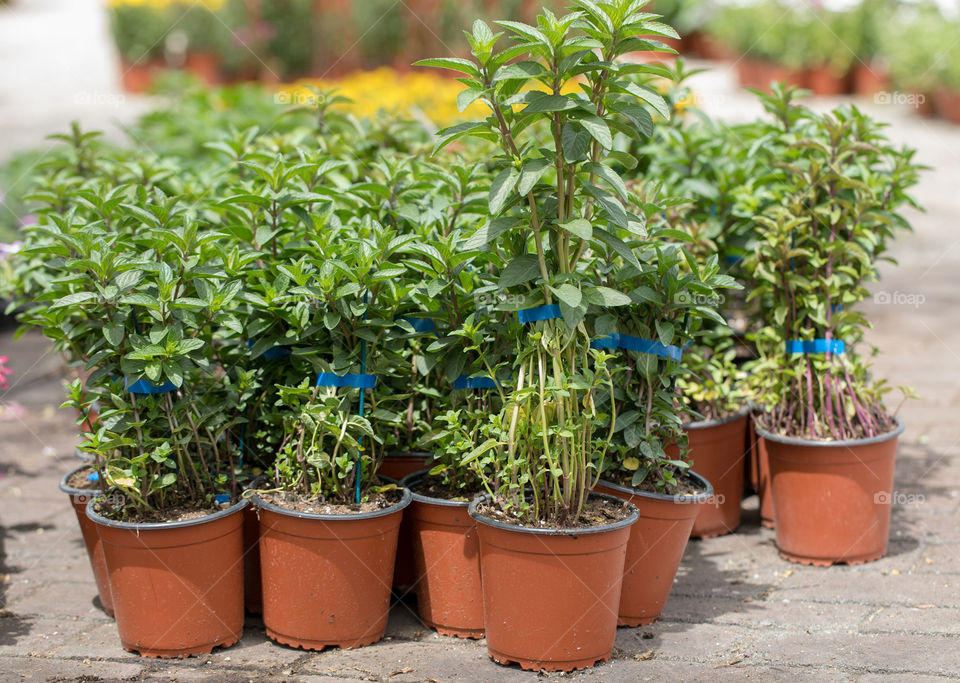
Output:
(87, 500), (248, 657)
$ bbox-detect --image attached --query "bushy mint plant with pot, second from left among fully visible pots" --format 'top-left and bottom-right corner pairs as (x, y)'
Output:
(242, 212), (411, 649)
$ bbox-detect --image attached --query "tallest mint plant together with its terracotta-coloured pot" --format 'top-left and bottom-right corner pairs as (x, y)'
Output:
(419, 0), (692, 670)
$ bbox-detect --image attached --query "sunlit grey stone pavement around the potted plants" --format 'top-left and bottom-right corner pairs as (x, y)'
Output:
(0, 0), (960, 682)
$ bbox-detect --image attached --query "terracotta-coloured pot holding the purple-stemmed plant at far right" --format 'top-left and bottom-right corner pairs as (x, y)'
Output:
(757, 420), (903, 567)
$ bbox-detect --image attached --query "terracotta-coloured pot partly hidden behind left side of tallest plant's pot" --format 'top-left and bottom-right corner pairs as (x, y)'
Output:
(403, 470), (483, 638)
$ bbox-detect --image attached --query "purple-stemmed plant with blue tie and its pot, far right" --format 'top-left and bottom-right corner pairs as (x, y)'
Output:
(749, 96), (918, 565)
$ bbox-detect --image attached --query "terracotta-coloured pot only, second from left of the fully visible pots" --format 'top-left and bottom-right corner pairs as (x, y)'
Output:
(253, 490), (412, 650)
